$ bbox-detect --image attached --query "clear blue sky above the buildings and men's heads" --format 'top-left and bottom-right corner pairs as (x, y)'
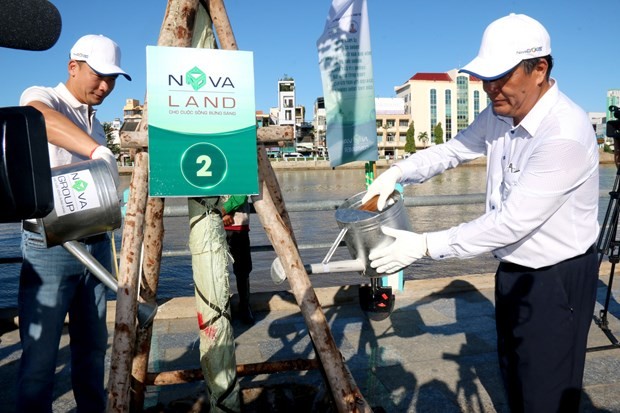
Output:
(0, 0), (620, 122)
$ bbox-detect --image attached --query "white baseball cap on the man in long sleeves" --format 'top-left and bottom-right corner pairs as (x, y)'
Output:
(459, 13), (551, 80)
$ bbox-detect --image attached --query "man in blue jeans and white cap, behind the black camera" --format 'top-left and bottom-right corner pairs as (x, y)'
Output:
(17, 35), (131, 413)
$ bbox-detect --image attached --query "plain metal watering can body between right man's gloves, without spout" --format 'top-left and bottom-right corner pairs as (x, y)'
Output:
(336, 191), (412, 277)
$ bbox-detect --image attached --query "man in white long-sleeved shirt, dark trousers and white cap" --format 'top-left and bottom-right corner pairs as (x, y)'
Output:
(363, 14), (599, 413)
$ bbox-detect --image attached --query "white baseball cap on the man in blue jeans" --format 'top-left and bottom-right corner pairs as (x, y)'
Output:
(71, 34), (131, 80)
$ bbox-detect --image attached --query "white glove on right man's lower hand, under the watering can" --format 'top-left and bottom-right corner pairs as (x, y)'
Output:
(368, 226), (427, 274)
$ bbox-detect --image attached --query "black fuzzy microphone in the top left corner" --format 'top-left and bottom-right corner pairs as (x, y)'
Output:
(0, 0), (62, 50)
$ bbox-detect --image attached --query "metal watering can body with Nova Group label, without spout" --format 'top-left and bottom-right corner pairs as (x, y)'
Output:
(39, 159), (122, 247)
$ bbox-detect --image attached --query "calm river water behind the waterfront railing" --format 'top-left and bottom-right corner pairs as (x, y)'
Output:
(0, 165), (616, 308)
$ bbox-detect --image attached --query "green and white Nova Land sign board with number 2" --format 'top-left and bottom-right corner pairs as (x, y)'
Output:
(146, 46), (258, 197)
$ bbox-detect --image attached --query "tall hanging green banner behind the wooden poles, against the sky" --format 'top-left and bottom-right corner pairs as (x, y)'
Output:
(317, 0), (378, 166)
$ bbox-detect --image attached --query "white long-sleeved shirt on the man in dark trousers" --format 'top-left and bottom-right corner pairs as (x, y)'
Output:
(397, 80), (599, 268)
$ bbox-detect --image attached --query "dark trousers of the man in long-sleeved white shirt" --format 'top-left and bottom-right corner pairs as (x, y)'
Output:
(495, 246), (598, 413)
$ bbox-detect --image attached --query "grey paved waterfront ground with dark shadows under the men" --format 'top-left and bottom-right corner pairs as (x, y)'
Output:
(0, 263), (620, 413)
